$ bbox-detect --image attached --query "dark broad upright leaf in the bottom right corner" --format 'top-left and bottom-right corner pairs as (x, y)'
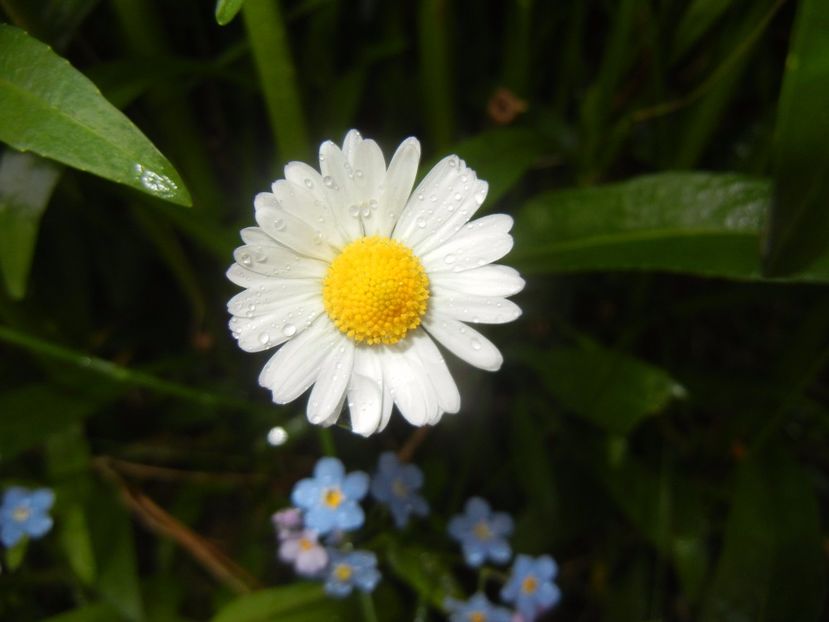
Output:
(700, 453), (826, 622)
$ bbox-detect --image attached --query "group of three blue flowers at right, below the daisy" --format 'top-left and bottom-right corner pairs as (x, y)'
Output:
(446, 497), (561, 622)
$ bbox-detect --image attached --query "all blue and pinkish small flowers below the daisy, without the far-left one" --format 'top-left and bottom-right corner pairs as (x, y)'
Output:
(273, 452), (561, 622)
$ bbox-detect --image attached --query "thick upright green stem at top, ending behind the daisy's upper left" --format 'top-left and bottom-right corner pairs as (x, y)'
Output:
(242, 0), (308, 161)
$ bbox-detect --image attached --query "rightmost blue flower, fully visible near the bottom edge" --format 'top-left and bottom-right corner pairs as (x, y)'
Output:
(501, 555), (561, 622)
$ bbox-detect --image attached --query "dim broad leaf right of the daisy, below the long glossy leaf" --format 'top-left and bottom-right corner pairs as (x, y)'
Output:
(520, 347), (685, 434)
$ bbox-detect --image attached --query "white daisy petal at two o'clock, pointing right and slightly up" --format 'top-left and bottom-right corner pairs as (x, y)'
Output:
(420, 214), (513, 273)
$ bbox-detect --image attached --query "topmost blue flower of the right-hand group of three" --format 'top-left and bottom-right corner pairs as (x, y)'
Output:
(449, 497), (513, 567)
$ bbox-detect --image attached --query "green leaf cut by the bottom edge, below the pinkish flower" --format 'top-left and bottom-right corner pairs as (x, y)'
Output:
(213, 582), (356, 622)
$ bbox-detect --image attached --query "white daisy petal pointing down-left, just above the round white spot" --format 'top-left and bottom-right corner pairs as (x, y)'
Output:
(259, 315), (340, 404)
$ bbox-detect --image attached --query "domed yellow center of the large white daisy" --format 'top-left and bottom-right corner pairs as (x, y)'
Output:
(322, 235), (429, 345)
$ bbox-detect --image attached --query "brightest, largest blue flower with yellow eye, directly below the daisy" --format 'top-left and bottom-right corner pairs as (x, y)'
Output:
(291, 458), (368, 536)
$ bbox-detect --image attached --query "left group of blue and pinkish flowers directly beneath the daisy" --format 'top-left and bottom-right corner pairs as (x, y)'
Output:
(273, 453), (429, 597)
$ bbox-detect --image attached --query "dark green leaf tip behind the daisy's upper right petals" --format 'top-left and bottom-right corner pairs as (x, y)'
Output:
(452, 127), (550, 209)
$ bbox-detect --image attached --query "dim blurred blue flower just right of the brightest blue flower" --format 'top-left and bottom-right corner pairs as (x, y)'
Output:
(371, 451), (429, 529)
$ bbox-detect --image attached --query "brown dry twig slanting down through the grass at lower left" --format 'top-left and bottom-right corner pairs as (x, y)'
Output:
(94, 457), (259, 594)
